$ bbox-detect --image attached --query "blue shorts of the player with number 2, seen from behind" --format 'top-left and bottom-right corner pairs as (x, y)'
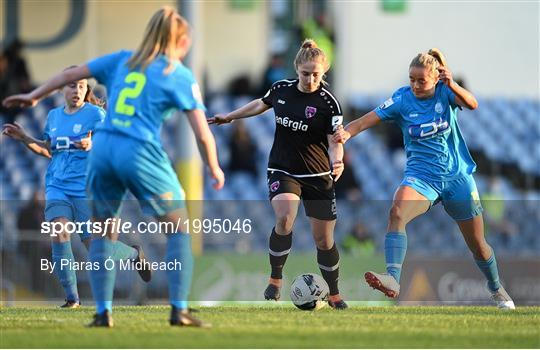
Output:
(87, 131), (185, 219)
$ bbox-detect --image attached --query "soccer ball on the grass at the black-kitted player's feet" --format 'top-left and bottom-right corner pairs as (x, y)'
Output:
(291, 273), (330, 310)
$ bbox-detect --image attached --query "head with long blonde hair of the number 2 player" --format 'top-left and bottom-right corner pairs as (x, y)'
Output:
(127, 6), (189, 74)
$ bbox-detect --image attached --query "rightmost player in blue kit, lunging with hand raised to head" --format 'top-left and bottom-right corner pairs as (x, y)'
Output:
(334, 49), (515, 309)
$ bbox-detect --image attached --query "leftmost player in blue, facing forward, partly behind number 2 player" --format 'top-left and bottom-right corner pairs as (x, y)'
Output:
(3, 79), (146, 308)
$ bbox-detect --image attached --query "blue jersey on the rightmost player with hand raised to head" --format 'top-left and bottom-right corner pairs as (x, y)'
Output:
(375, 82), (476, 181)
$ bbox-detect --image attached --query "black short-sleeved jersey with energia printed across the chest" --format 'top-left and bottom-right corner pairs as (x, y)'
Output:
(262, 79), (343, 176)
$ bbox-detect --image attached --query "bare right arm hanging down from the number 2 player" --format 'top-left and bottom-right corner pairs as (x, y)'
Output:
(186, 109), (225, 190)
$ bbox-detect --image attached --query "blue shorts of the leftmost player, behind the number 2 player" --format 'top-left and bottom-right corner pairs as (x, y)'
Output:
(45, 187), (91, 241)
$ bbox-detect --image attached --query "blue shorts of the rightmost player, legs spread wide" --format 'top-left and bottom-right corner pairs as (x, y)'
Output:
(400, 175), (483, 221)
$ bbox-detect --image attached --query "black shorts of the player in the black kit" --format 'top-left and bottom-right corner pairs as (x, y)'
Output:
(267, 171), (337, 220)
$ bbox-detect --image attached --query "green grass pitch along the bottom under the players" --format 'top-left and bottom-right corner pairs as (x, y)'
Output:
(0, 305), (540, 348)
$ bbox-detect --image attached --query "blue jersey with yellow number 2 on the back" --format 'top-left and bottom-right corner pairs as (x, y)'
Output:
(88, 51), (206, 145)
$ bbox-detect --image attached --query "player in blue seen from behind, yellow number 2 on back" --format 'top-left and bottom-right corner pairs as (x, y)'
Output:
(4, 7), (224, 327)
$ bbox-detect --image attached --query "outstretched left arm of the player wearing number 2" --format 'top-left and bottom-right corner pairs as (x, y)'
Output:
(2, 65), (92, 108)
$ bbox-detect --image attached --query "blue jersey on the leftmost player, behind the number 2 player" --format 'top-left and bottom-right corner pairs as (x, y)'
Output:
(43, 103), (105, 197)
